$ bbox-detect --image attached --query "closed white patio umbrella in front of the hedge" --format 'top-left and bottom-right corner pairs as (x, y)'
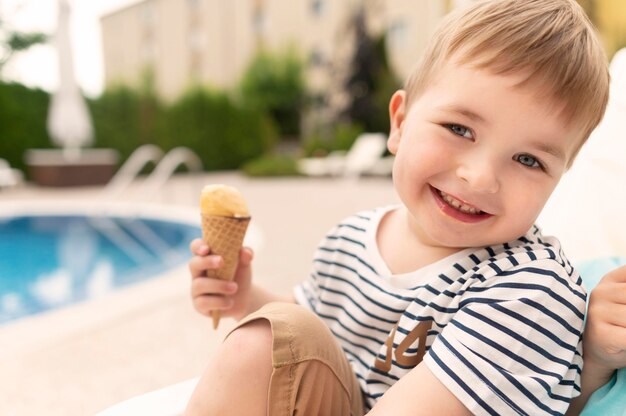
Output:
(47, 0), (93, 158)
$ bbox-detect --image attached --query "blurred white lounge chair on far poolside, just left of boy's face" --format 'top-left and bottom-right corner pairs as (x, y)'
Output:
(298, 133), (391, 177)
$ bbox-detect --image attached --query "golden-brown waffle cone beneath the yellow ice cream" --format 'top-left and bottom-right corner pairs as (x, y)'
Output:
(202, 214), (250, 280)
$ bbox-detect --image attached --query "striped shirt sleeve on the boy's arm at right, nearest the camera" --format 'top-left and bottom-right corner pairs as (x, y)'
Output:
(425, 260), (586, 415)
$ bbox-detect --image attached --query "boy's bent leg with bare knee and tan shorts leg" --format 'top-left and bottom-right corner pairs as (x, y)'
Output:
(183, 303), (364, 416)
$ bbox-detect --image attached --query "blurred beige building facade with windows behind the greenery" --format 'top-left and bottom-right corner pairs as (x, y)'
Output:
(101, 0), (446, 100)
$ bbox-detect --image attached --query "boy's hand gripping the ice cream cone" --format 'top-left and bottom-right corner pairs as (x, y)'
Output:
(189, 238), (253, 319)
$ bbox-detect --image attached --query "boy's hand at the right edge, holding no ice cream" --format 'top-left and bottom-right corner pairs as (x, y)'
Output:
(583, 266), (626, 373)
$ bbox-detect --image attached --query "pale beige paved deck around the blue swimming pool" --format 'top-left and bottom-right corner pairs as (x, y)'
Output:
(0, 173), (397, 416)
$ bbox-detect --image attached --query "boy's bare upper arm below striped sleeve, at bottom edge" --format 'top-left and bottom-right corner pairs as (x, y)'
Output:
(367, 362), (472, 416)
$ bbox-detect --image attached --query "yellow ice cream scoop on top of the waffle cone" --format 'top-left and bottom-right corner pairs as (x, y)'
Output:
(200, 185), (250, 217)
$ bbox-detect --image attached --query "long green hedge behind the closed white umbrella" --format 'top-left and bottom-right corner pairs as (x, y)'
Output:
(0, 83), (277, 176)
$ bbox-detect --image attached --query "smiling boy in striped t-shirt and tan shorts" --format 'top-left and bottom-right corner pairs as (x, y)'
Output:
(187, 0), (609, 416)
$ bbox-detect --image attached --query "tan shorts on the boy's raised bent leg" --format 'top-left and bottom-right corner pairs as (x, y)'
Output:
(228, 303), (364, 416)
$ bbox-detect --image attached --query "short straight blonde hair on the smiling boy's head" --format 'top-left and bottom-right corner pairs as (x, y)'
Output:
(405, 0), (609, 160)
